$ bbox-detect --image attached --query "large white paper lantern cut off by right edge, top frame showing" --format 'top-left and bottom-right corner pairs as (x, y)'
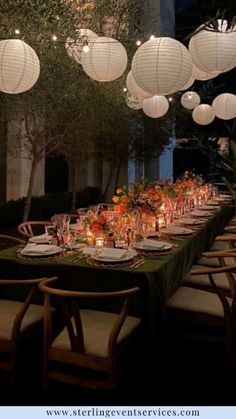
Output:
(189, 19), (236, 73)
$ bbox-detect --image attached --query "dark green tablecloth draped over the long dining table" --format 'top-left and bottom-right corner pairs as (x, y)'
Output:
(0, 205), (233, 375)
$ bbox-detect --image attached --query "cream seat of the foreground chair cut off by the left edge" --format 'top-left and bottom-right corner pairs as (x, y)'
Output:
(0, 300), (43, 340)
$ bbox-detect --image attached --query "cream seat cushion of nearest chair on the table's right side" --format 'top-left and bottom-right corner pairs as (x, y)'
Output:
(167, 286), (233, 318)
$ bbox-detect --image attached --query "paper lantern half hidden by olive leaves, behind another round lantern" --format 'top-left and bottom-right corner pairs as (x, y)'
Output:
(65, 29), (98, 64)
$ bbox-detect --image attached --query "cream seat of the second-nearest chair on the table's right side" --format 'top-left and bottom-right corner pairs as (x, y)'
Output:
(182, 265), (236, 291)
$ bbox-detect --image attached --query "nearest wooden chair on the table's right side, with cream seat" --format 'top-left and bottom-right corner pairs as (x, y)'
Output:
(167, 264), (236, 372)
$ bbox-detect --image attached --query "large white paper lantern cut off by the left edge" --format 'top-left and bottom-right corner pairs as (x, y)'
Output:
(0, 39), (40, 94)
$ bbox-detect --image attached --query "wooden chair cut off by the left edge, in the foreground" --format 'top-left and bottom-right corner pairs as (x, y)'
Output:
(0, 278), (54, 386)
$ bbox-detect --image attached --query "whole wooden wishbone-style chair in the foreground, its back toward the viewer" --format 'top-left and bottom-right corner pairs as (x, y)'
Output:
(39, 279), (141, 389)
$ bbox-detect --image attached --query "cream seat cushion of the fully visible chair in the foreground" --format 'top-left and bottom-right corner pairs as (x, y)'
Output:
(51, 310), (141, 358)
